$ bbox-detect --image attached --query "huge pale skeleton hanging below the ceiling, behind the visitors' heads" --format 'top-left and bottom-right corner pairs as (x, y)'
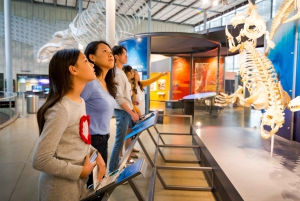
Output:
(37, 0), (149, 62)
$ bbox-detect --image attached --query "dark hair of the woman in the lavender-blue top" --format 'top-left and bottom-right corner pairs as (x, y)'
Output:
(84, 40), (117, 98)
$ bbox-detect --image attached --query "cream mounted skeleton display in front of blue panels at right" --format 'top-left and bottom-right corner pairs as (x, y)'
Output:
(215, 0), (300, 139)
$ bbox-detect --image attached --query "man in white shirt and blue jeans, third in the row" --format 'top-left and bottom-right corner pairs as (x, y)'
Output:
(109, 46), (139, 172)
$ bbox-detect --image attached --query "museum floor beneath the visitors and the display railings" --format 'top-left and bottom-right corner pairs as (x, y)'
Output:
(0, 100), (218, 201)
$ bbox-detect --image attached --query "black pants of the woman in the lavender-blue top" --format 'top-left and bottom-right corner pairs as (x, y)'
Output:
(87, 134), (109, 186)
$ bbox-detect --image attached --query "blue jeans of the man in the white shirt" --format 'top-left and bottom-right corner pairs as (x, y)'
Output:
(108, 109), (131, 173)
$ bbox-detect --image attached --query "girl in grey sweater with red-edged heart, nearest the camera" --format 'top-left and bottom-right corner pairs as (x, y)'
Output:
(33, 49), (106, 201)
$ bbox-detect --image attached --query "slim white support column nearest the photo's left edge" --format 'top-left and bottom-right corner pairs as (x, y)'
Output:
(4, 0), (13, 92)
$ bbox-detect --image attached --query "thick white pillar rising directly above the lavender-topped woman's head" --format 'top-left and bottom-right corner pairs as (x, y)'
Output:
(106, 0), (116, 47)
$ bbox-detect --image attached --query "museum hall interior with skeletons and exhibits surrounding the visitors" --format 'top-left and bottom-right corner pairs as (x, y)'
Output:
(0, 0), (300, 201)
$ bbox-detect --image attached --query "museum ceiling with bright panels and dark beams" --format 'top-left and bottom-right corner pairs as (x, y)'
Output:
(13, 0), (248, 26)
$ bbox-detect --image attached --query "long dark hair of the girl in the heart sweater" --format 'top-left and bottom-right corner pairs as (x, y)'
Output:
(37, 49), (80, 135)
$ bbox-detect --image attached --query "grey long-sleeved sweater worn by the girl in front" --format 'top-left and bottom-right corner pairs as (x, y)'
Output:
(33, 97), (95, 200)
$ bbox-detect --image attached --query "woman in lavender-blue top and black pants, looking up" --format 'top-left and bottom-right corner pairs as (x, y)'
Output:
(81, 41), (117, 185)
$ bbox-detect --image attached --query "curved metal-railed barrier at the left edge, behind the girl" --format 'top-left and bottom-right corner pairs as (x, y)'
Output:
(0, 91), (19, 129)
